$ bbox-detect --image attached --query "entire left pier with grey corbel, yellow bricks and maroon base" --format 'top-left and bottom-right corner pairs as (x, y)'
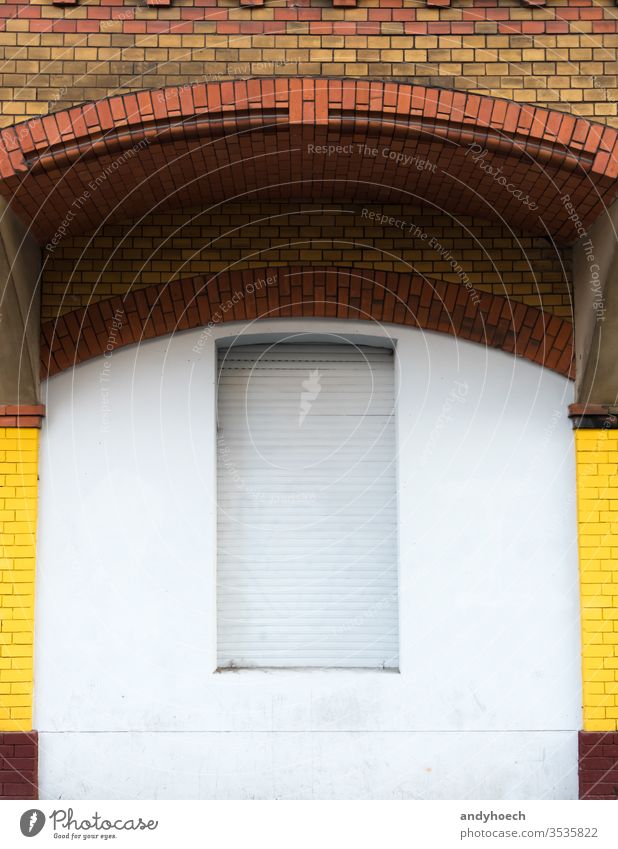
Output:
(0, 201), (44, 799)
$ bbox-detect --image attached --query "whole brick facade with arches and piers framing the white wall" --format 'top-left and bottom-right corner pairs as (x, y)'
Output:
(0, 0), (618, 798)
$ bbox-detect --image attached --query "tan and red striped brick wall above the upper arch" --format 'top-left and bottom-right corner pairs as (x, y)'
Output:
(0, 0), (618, 127)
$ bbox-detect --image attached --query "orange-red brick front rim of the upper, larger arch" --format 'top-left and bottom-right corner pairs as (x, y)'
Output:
(0, 77), (618, 179)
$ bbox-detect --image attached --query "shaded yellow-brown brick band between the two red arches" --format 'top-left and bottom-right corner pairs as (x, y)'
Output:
(43, 203), (572, 320)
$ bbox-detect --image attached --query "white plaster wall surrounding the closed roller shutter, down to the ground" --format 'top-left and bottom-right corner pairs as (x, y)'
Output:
(34, 321), (581, 798)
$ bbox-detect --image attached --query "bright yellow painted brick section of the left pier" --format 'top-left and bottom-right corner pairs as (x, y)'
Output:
(0, 428), (39, 731)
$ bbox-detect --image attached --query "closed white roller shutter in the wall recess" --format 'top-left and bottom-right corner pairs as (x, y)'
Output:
(217, 343), (398, 668)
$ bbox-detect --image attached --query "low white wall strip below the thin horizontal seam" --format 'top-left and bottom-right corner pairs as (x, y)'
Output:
(39, 731), (577, 799)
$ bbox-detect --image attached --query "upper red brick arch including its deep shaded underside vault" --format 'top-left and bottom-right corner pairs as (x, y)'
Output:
(0, 78), (618, 242)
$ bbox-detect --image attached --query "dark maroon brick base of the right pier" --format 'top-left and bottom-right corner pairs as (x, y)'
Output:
(579, 731), (618, 800)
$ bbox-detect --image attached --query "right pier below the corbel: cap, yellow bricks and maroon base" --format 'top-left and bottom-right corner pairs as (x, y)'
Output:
(571, 405), (618, 799)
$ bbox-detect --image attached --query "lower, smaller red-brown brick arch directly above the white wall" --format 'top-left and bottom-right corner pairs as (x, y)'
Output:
(41, 267), (573, 378)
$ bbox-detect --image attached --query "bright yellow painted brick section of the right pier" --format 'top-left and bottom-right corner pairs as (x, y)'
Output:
(575, 430), (618, 731)
